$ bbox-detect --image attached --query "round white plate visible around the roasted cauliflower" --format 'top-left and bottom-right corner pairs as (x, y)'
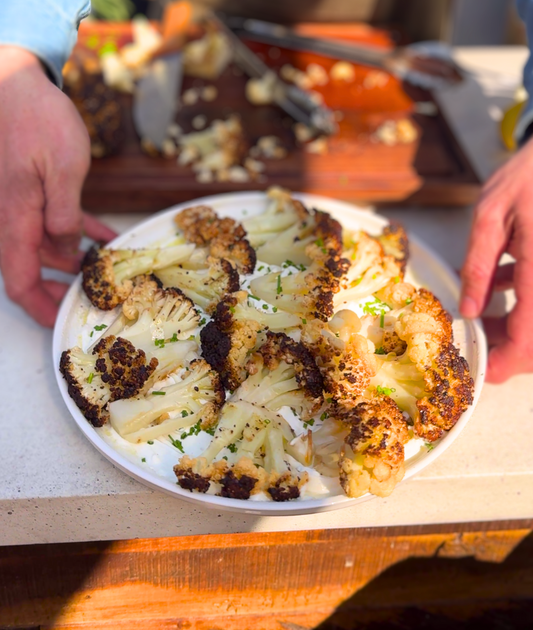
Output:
(53, 192), (487, 516)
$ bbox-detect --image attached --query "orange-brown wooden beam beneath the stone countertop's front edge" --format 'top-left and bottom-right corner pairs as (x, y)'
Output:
(0, 529), (533, 630)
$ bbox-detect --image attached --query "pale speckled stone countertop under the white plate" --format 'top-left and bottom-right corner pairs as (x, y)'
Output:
(0, 48), (533, 545)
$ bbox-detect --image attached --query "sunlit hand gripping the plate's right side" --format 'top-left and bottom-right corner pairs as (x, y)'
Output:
(460, 141), (533, 383)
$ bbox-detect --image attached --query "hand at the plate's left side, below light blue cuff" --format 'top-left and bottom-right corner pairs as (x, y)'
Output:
(0, 46), (115, 327)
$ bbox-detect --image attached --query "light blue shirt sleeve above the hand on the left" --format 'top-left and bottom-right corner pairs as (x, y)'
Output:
(0, 0), (91, 87)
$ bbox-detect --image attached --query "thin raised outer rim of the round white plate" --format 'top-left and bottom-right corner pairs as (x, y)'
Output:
(52, 190), (487, 516)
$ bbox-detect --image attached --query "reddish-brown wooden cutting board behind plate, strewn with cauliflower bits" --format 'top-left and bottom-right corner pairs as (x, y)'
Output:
(79, 22), (480, 212)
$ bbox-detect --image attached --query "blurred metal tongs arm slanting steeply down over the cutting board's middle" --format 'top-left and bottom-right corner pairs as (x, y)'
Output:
(213, 14), (338, 135)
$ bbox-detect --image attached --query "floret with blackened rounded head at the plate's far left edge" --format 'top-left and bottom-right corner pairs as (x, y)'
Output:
(59, 335), (157, 427)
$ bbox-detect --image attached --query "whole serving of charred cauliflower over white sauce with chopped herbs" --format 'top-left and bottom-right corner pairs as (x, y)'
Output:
(61, 188), (473, 502)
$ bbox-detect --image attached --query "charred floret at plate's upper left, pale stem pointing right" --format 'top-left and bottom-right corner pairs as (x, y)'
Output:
(81, 245), (194, 311)
